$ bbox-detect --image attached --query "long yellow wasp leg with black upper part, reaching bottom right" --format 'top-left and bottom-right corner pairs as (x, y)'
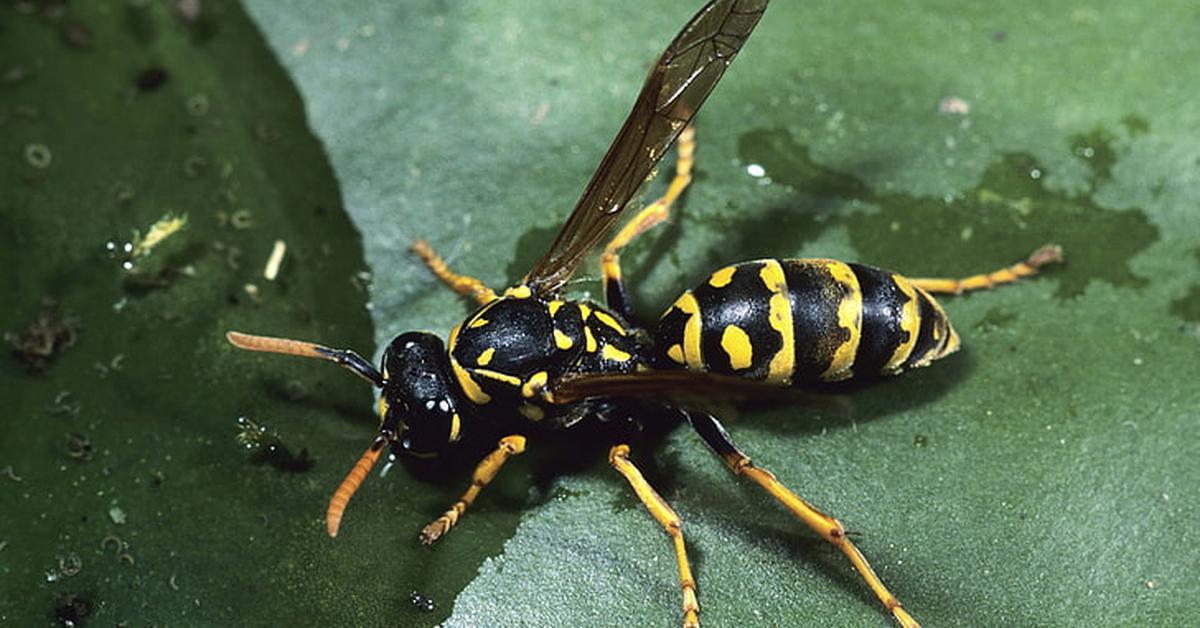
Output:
(688, 412), (920, 628)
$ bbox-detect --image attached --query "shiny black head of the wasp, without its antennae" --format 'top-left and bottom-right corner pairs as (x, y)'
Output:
(383, 331), (461, 456)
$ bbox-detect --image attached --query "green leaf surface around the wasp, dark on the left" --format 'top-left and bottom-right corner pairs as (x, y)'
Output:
(0, 0), (1200, 627)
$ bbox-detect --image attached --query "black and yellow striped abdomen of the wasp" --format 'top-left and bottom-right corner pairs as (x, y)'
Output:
(654, 259), (959, 385)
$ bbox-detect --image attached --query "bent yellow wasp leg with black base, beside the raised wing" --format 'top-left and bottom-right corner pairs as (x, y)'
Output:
(600, 126), (696, 321)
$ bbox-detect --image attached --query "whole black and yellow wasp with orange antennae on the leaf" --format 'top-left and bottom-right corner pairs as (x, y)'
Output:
(227, 0), (1061, 627)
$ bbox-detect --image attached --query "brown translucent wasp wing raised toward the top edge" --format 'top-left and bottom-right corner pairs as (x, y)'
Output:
(524, 0), (768, 297)
